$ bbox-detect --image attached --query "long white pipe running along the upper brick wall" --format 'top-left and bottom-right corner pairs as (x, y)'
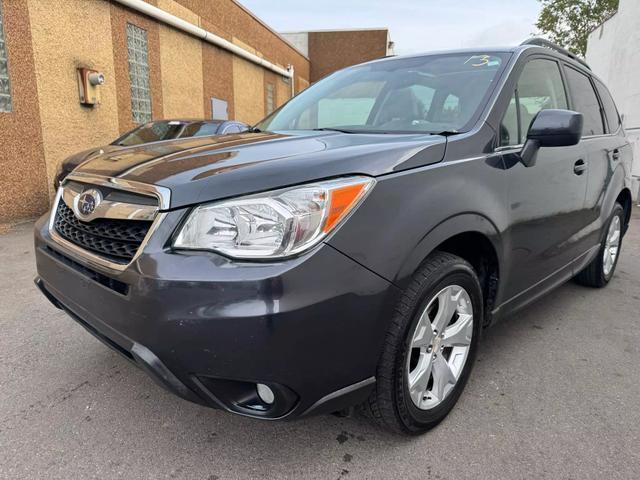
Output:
(113, 0), (294, 80)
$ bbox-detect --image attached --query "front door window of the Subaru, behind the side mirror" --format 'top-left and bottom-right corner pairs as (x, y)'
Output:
(501, 58), (567, 145)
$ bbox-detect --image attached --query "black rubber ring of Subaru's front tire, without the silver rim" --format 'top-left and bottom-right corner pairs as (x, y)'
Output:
(395, 262), (483, 433)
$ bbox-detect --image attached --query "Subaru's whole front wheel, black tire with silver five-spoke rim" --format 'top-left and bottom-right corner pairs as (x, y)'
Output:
(360, 252), (483, 435)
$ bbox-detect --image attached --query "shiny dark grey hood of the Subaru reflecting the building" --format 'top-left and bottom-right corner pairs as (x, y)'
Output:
(74, 132), (446, 208)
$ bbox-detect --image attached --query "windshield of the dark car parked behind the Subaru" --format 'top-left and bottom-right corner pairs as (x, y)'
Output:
(113, 120), (220, 147)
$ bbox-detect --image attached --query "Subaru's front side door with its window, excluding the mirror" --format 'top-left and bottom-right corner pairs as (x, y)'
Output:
(500, 56), (587, 303)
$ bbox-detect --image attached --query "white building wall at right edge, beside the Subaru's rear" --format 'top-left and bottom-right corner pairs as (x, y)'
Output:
(587, 0), (640, 201)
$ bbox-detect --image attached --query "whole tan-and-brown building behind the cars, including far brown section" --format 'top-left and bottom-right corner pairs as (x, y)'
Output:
(0, 0), (388, 224)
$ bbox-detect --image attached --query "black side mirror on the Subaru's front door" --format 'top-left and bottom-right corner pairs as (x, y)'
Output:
(520, 110), (584, 167)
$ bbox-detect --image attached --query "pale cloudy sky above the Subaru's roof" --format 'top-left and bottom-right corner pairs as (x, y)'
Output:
(240, 0), (540, 55)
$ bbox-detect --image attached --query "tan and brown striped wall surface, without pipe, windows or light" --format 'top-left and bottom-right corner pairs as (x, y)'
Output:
(0, 0), (310, 223)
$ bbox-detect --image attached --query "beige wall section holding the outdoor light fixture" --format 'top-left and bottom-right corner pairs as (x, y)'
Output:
(28, 0), (118, 194)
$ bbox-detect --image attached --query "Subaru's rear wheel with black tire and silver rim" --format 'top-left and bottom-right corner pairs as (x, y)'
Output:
(575, 203), (624, 288)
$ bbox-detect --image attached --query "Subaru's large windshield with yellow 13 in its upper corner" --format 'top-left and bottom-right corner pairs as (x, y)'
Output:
(256, 53), (509, 133)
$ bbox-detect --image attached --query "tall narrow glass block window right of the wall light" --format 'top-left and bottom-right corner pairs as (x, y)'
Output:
(127, 23), (151, 123)
